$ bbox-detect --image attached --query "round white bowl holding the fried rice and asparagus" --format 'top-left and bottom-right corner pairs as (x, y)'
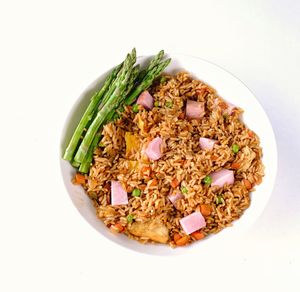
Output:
(60, 55), (277, 255)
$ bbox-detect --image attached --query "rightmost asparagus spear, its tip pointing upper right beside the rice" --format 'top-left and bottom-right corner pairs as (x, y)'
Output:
(125, 59), (171, 105)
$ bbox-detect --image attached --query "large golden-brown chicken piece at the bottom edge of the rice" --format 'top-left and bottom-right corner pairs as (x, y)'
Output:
(127, 219), (169, 243)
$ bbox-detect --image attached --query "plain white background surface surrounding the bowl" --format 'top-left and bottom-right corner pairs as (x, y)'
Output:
(0, 0), (300, 292)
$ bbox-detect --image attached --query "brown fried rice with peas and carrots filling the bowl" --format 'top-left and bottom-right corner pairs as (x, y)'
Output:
(84, 72), (264, 247)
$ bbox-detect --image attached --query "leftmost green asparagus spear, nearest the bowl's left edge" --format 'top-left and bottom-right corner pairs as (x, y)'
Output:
(63, 64), (122, 161)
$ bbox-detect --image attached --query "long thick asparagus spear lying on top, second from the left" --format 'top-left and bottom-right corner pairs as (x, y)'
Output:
(74, 49), (136, 163)
